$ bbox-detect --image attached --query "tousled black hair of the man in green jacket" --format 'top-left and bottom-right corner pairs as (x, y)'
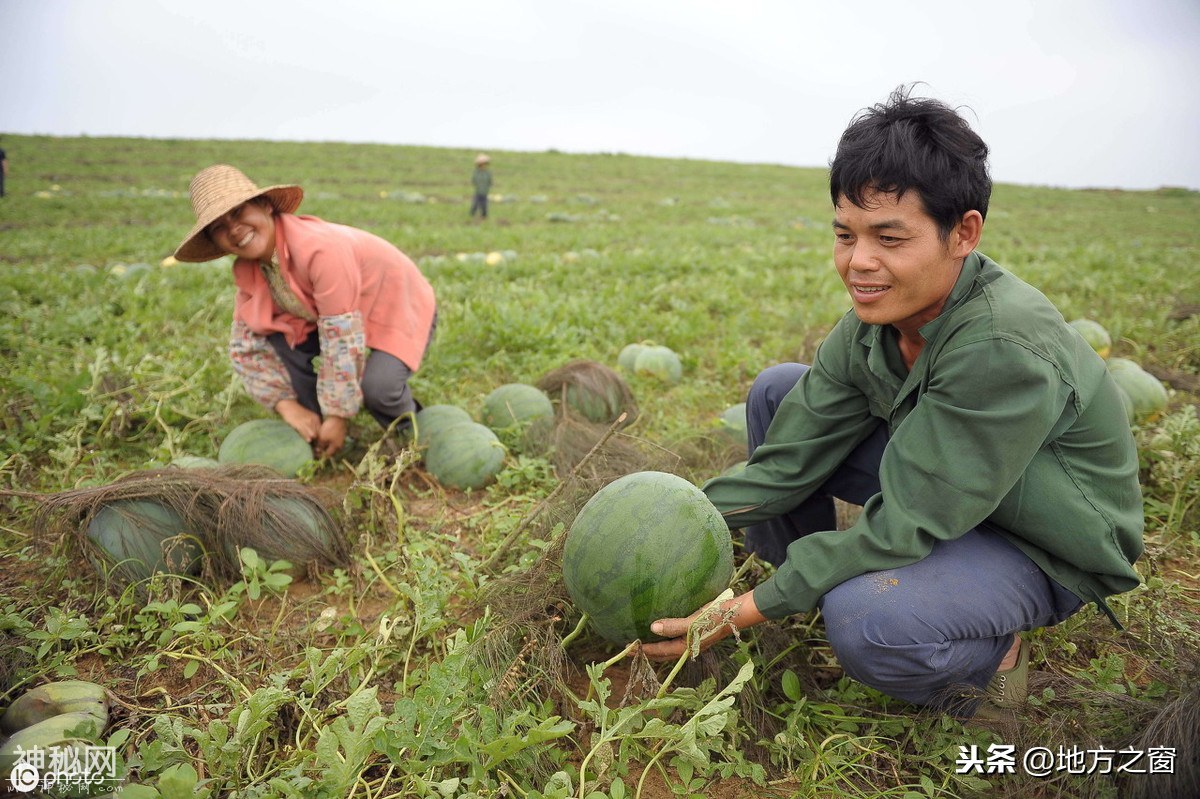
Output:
(829, 86), (991, 240)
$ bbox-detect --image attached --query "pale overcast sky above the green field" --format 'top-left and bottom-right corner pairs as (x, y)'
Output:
(0, 0), (1200, 188)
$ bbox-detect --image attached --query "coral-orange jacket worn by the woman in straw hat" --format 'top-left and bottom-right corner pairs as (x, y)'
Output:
(233, 214), (437, 372)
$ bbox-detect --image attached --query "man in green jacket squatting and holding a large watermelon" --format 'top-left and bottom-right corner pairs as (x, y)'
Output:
(644, 83), (1144, 719)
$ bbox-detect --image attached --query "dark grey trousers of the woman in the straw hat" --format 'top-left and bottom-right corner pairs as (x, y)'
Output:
(266, 330), (422, 429)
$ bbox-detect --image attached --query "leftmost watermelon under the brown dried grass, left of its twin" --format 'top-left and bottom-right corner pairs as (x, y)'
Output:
(86, 499), (200, 581)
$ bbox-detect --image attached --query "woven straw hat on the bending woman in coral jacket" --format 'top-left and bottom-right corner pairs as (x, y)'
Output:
(175, 163), (304, 263)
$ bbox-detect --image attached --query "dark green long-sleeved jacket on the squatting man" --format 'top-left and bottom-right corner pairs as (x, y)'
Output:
(704, 253), (1144, 623)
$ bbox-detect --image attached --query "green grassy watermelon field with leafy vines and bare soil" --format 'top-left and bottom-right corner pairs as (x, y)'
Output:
(0, 136), (1200, 799)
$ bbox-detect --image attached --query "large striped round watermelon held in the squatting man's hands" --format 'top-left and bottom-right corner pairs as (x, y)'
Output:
(563, 471), (733, 644)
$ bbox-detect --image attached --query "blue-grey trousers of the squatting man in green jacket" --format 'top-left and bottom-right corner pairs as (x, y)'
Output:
(745, 364), (1082, 715)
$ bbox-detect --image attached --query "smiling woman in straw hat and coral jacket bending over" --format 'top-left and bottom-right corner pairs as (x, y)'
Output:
(175, 164), (437, 456)
